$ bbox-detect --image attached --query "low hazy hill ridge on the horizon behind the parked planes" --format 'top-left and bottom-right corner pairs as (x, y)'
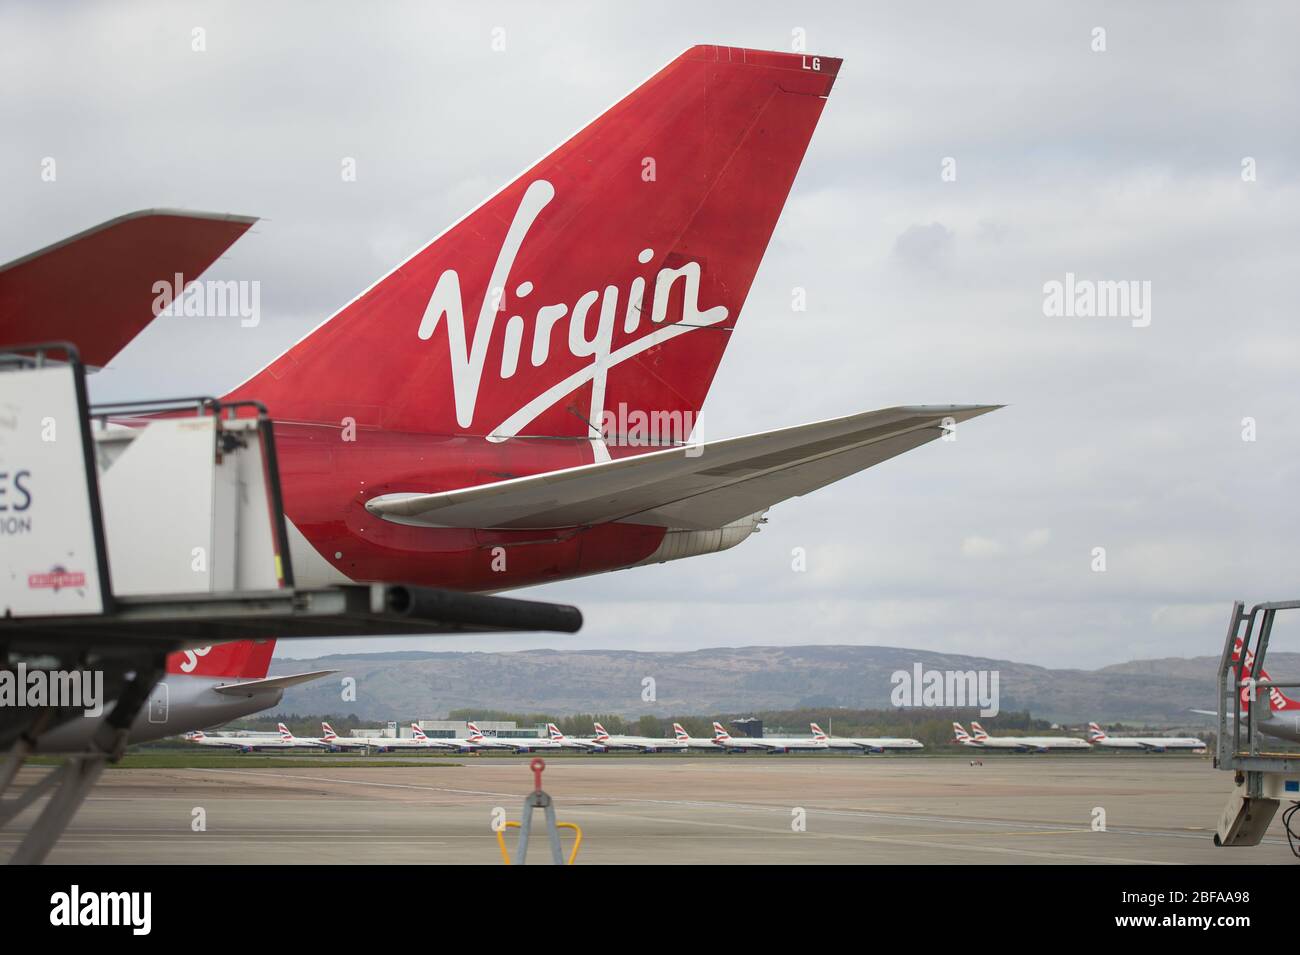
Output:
(272, 646), (1300, 725)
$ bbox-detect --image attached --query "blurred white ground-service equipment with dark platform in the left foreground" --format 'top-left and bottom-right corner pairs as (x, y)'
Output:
(0, 343), (582, 863)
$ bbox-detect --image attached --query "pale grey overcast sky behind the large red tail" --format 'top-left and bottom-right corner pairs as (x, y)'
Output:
(0, 0), (1300, 667)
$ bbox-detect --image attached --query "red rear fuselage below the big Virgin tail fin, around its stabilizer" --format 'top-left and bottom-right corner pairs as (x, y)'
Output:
(276, 423), (666, 591)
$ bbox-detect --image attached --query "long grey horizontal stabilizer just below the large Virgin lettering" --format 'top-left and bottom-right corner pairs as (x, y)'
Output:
(367, 405), (1000, 530)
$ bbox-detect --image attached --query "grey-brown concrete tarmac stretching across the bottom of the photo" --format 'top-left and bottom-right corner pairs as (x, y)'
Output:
(0, 754), (1296, 865)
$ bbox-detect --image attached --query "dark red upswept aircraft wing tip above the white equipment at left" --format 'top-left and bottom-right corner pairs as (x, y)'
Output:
(0, 209), (257, 368)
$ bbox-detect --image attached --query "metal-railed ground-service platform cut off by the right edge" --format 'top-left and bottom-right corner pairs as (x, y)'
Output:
(1214, 600), (1300, 856)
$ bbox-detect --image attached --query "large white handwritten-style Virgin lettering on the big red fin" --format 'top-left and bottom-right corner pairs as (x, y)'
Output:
(417, 179), (728, 440)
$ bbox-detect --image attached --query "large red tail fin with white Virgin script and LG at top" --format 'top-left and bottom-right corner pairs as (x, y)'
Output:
(234, 47), (840, 440)
